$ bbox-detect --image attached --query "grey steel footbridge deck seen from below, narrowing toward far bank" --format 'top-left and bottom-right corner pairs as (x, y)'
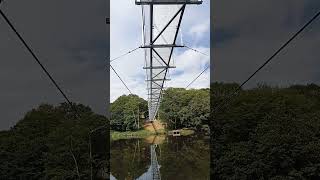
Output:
(135, 0), (202, 121)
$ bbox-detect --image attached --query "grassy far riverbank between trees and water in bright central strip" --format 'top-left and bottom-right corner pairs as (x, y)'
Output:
(110, 129), (195, 141)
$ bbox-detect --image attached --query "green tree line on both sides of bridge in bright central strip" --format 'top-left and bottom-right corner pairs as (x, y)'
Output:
(110, 88), (210, 131)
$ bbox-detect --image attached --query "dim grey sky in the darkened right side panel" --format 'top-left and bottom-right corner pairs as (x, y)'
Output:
(211, 0), (320, 88)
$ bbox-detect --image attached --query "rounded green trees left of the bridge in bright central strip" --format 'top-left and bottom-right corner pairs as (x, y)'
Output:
(110, 95), (148, 131)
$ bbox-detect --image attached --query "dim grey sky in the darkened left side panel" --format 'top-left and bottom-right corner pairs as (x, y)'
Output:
(0, 0), (109, 130)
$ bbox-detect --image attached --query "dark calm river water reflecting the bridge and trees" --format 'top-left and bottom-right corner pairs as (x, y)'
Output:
(110, 136), (210, 180)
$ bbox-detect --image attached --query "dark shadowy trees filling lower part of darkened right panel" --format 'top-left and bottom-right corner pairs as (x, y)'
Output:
(210, 83), (320, 179)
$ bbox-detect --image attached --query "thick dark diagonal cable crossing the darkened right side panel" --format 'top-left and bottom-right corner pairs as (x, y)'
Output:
(216, 11), (320, 111)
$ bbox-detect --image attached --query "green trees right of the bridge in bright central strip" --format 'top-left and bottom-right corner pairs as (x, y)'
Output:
(159, 88), (210, 129)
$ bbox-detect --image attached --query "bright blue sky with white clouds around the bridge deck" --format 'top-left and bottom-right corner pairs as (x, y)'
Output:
(110, 0), (210, 102)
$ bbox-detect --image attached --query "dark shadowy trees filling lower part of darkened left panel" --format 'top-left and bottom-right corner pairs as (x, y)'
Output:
(0, 103), (109, 179)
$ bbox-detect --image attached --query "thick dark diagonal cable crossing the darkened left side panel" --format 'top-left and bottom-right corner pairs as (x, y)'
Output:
(0, 10), (80, 117)
